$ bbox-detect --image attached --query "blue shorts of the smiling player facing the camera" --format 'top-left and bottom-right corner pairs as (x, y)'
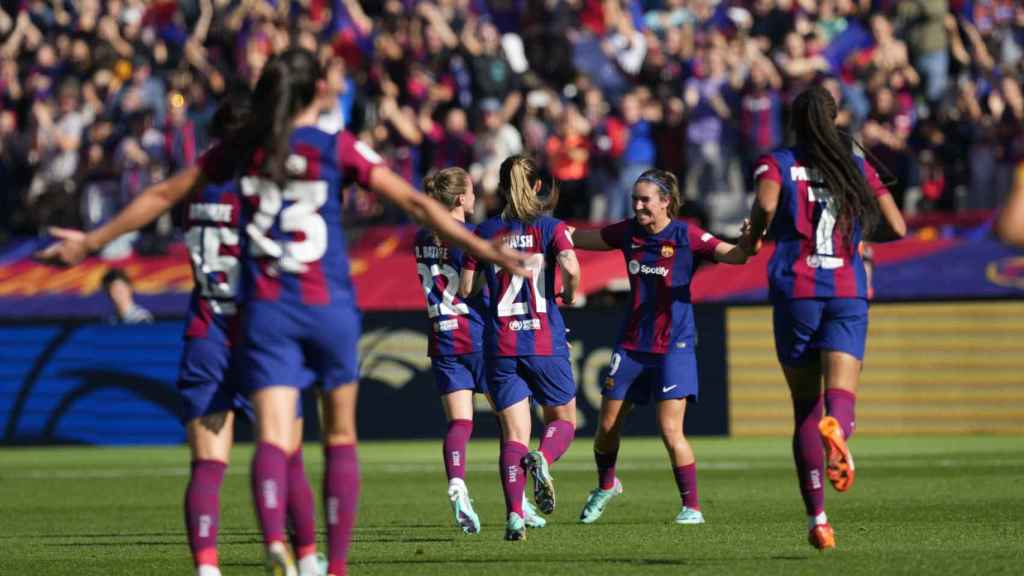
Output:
(601, 347), (698, 405)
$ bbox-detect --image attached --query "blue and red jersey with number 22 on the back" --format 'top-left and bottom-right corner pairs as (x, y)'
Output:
(413, 224), (486, 357)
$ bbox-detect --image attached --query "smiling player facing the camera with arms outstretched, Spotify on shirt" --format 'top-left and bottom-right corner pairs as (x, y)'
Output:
(572, 169), (746, 524)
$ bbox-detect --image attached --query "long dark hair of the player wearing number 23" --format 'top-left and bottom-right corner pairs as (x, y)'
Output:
(236, 48), (321, 187)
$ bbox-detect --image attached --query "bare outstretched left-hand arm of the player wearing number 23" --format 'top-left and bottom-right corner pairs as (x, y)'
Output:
(35, 167), (206, 265)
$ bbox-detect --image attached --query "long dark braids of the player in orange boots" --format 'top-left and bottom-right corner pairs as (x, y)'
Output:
(792, 86), (879, 242)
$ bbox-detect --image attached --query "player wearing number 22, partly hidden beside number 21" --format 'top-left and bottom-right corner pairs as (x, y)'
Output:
(414, 167), (546, 534)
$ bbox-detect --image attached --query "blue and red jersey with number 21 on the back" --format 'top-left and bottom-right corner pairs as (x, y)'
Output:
(463, 216), (572, 357)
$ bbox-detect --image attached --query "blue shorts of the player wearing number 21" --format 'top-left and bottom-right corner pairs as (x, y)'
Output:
(486, 356), (575, 411)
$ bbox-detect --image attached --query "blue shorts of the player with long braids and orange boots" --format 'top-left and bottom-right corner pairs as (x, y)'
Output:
(772, 298), (867, 366)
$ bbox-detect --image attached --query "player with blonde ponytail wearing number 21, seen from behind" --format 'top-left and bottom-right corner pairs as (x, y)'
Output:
(459, 156), (580, 540)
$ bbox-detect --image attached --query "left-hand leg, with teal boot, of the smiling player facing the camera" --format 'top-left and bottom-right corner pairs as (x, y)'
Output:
(580, 398), (633, 524)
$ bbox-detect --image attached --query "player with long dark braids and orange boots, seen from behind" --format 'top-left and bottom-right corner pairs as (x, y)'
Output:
(744, 86), (906, 549)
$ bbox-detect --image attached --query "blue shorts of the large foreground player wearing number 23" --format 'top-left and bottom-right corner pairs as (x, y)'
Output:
(241, 300), (361, 394)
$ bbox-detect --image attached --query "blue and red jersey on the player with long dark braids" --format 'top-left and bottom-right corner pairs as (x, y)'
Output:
(754, 148), (889, 299)
